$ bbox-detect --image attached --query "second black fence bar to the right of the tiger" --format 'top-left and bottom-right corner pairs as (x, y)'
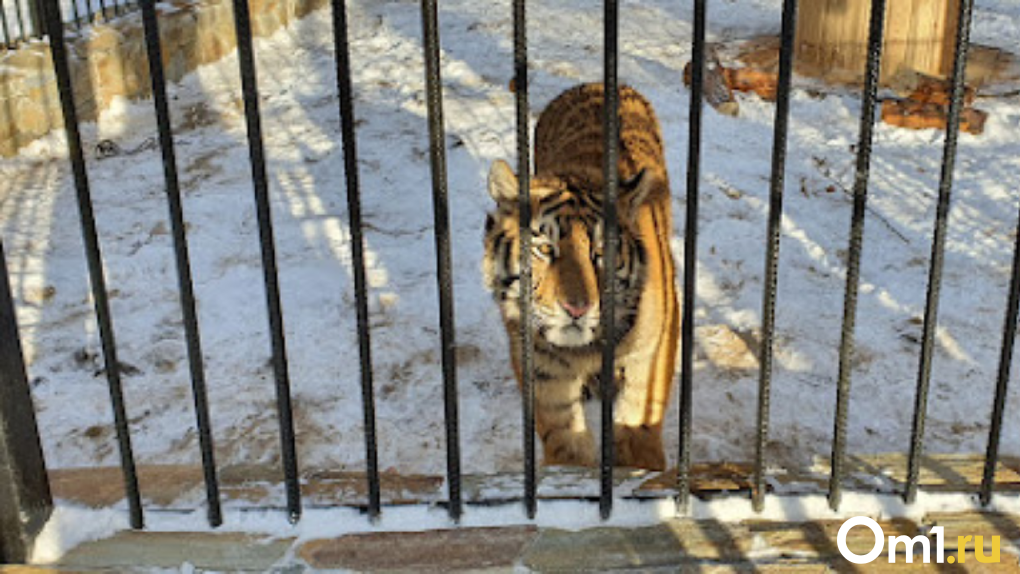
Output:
(752, 0), (797, 512)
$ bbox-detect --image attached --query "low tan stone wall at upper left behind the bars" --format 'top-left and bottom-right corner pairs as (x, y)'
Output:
(0, 0), (327, 157)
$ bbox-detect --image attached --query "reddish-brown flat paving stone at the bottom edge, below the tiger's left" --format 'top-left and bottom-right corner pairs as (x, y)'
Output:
(297, 526), (538, 572)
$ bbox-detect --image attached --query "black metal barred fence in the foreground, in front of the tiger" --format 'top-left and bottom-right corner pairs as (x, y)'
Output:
(0, 0), (1020, 561)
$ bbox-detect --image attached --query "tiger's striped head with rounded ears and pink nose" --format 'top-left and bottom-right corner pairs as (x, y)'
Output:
(483, 160), (657, 349)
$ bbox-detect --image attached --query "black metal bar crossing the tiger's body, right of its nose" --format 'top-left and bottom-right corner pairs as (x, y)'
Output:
(599, 0), (620, 520)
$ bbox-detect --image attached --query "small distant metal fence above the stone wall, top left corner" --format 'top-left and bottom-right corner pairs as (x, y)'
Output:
(0, 0), (139, 50)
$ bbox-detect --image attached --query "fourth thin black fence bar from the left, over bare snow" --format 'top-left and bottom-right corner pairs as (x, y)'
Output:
(333, 0), (380, 519)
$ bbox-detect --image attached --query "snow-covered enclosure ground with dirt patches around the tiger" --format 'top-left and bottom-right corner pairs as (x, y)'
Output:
(0, 0), (1020, 485)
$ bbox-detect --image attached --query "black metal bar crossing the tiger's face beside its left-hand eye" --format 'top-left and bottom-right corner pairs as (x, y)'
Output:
(513, 0), (538, 518)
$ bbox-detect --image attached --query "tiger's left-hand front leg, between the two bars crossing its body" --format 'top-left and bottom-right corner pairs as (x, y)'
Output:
(534, 373), (596, 466)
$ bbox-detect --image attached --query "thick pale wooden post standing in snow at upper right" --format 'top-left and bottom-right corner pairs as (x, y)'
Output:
(797, 0), (960, 82)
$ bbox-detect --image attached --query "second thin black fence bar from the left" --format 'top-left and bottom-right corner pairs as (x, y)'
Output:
(142, 0), (223, 527)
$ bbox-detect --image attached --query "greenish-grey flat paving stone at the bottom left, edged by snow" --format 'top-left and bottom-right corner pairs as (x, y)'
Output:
(59, 531), (294, 572)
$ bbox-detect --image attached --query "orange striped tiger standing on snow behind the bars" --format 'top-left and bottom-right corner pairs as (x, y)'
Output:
(482, 84), (680, 470)
